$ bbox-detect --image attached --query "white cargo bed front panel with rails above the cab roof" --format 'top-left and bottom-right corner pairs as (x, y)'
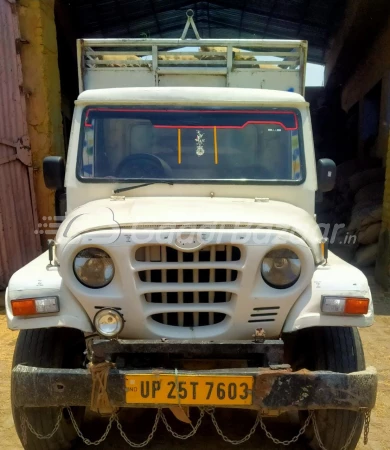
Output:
(77, 39), (307, 95)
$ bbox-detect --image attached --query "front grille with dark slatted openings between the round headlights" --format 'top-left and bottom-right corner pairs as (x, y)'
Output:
(135, 245), (241, 327)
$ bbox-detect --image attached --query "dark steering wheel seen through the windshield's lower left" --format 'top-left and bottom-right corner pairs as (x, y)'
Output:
(115, 153), (172, 178)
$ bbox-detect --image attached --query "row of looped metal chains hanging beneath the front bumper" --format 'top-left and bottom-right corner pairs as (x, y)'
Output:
(20, 407), (371, 450)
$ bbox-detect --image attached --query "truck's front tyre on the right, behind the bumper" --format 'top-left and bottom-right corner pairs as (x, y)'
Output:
(297, 327), (365, 450)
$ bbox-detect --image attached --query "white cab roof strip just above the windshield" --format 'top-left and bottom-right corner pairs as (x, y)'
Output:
(76, 87), (305, 106)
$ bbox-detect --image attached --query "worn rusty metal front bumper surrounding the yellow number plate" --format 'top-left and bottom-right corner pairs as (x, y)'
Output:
(12, 365), (377, 411)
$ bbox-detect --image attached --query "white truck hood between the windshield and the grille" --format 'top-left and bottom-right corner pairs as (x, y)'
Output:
(56, 197), (322, 262)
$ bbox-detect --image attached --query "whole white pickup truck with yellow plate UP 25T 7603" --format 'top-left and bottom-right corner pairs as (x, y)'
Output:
(6, 20), (377, 450)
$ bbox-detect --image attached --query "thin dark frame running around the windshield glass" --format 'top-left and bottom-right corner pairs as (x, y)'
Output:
(76, 104), (306, 186)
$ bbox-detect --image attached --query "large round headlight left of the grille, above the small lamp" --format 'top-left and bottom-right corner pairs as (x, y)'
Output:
(73, 247), (115, 289)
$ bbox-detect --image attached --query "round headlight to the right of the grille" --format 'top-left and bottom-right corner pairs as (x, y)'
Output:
(261, 248), (301, 289)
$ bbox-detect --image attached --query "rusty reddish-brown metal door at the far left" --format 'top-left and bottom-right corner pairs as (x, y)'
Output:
(0, 0), (41, 289)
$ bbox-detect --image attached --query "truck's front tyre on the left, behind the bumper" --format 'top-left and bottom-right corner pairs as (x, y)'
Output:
(11, 328), (85, 450)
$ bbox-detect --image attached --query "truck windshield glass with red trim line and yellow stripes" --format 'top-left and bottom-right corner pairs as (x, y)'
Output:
(77, 107), (304, 183)
